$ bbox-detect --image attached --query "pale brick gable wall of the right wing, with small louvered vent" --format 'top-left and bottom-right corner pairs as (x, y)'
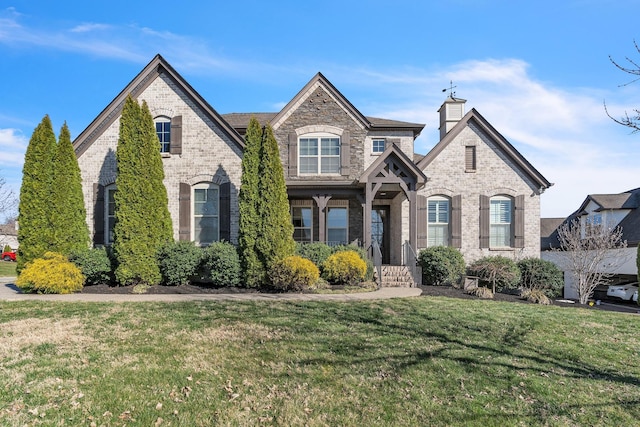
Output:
(419, 125), (540, 263)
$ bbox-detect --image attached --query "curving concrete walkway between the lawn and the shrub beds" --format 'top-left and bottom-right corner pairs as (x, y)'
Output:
(0, 277), (422, 302)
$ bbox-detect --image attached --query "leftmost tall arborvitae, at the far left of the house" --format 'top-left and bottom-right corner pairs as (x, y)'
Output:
(17, 115), (56, 274)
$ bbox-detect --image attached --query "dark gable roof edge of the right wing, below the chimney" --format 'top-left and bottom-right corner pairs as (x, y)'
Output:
(418, 108), (553, 190)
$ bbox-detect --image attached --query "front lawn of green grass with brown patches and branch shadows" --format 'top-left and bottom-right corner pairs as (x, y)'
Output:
(0, 297), (640, 426)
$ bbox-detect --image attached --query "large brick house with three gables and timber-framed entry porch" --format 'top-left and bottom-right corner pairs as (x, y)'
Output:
(74, 55), (551, 274)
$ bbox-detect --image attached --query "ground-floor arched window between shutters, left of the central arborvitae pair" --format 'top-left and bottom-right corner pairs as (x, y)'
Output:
(192, 183), (220, 246)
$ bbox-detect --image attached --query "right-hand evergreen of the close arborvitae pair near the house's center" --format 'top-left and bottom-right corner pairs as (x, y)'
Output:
(256, 125), (296, 271)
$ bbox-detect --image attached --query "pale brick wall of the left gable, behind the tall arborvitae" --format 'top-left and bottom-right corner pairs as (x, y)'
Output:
(78, 75), (242, 243)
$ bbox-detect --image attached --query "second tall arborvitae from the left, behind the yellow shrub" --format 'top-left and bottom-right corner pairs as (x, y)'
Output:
(51, 123), (89, 256)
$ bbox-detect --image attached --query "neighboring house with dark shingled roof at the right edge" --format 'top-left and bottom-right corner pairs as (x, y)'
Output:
(541, 188), (640, 299)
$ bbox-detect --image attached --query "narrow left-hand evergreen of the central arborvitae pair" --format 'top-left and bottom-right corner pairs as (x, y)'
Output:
(238, 117), (264, 287)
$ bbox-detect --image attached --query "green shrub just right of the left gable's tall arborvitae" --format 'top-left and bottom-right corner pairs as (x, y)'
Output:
(158, 241), (202, 285)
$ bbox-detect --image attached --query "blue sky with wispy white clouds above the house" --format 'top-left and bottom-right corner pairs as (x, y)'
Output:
(0, 0), (640, 221)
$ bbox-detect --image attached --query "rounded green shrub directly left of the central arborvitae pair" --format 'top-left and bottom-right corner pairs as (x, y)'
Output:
(201, 242), (240, 286)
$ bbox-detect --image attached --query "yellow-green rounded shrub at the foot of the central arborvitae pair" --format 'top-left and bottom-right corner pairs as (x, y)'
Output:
(269, 255), (320, 291)
